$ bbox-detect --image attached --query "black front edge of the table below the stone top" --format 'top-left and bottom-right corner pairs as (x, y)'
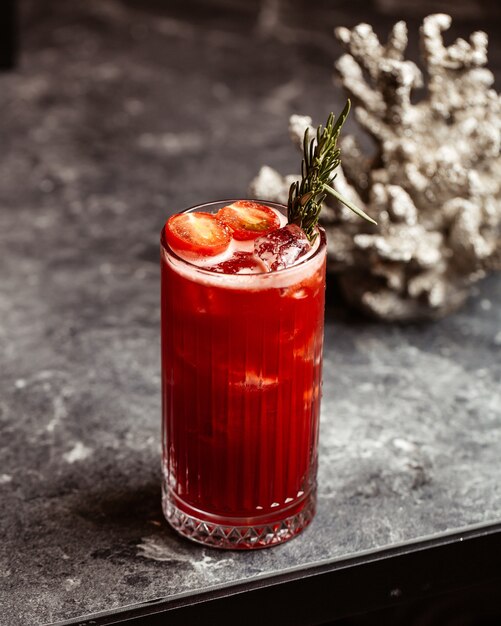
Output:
(47, 521), (501, 626)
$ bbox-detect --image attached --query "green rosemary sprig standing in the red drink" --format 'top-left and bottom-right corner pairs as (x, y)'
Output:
(287, 100), (376, 243)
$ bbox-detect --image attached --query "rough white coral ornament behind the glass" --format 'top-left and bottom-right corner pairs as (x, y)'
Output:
(251, 14), (501, 320)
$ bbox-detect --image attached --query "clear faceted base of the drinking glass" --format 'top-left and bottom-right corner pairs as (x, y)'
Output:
(162, 486), (316, 550)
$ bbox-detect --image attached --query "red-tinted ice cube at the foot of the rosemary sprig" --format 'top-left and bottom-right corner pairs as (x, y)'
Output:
(254, 224), (311, 272)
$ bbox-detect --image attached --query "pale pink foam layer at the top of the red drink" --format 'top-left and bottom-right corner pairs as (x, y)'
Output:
(162, 207), (325, 290)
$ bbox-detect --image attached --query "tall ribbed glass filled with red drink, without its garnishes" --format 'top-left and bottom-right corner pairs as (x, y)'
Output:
(161, 202), (326, 549)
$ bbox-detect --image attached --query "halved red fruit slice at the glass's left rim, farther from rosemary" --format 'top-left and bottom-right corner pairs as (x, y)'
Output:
(165, 212), (231, 256)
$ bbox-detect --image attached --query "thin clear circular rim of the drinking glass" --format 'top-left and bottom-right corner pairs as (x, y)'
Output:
(160, 198), (327, 279)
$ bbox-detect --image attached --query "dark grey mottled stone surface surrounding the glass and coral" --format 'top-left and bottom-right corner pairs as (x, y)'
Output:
(0, 0), (501, 626)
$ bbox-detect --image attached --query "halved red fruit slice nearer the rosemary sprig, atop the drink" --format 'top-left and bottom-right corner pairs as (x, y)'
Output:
(216, 200), (280, 241)
